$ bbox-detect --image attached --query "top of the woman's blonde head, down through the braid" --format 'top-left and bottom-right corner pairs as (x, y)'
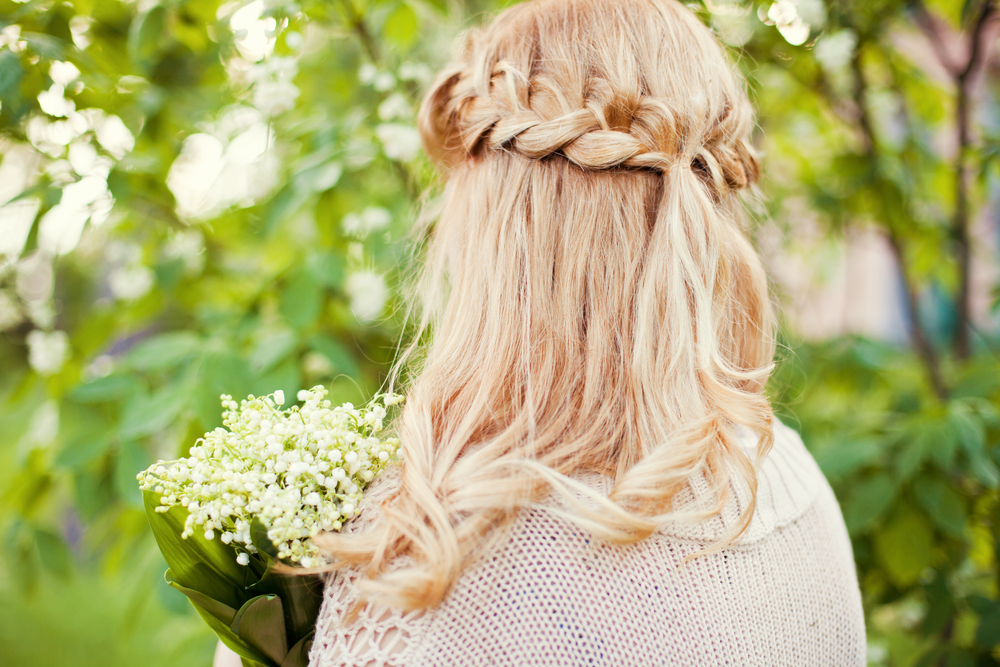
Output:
(421, 0), (759, 190)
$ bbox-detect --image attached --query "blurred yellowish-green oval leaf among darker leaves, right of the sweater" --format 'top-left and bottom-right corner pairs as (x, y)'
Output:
(874, 506), (934, 587)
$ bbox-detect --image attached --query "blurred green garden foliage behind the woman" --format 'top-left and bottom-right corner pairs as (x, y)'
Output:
(0, 0), (1000, 667)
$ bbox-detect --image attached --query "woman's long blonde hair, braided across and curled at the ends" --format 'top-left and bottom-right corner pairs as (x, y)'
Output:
(325, 0), (774, 609)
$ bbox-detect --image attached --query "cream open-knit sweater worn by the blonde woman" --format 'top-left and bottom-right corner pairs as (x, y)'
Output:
(309, 423), (866, 667)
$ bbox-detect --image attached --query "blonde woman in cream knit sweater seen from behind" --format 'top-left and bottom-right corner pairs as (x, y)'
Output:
(298, 0), (865, 667)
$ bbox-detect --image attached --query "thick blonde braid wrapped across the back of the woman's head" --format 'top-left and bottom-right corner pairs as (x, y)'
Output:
(422, 61), (760, 195)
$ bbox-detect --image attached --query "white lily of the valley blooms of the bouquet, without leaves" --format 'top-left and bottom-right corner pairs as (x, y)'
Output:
(138, 387), (403, 567)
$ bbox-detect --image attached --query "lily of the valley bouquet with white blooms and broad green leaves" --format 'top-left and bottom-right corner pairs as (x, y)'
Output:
(138, 387), (402, 667)
